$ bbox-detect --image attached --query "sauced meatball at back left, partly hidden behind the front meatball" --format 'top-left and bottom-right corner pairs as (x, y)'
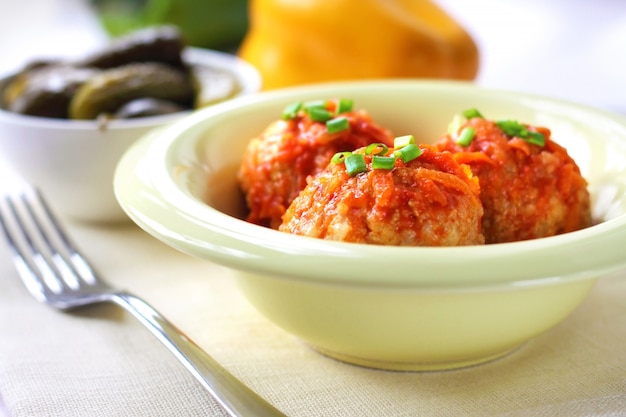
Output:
(238, 100), (393, 229)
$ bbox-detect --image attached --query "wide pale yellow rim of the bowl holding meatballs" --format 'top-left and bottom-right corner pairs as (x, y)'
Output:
(114, 79), (626, 290)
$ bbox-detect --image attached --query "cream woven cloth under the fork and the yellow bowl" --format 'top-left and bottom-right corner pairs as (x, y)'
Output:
(0, 214), (626, 417)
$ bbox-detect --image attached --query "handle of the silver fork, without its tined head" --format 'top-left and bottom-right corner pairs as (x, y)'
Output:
(111, 292), (285, 417)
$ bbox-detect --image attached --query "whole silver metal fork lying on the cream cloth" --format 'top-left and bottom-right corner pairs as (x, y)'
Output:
(0, 186), (284, 417)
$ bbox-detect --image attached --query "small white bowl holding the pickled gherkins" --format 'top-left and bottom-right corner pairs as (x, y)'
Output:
(0, 48), (261, 222)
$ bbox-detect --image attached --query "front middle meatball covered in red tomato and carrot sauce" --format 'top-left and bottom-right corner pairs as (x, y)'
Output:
(279, 145), (484, 246)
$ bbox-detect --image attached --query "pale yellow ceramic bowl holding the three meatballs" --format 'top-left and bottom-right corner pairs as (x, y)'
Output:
(115, 81), (626, 370)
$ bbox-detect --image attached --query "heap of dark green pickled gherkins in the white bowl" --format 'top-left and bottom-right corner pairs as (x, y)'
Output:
(0, 26), (241, 120)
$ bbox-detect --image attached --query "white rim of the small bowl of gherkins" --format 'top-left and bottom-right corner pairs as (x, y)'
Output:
(0, 46), (262, 131)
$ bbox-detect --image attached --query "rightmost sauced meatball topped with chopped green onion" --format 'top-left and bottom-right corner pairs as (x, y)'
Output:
(435, 116), (591, 243)
